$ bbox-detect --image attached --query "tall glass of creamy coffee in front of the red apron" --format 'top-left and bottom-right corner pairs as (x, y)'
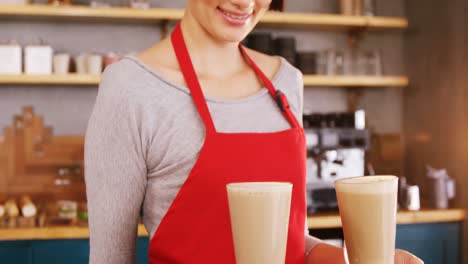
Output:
(227, 182), (292, 264)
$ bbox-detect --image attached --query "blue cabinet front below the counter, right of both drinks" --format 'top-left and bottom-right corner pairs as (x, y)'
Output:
(396, 223), (462, 264)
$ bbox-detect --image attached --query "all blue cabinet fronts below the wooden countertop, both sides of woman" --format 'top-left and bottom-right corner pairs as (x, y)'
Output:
(0, 223), (462, 264)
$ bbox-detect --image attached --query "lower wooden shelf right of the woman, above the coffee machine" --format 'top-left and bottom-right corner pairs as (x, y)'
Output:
(304, 75), (409, 87)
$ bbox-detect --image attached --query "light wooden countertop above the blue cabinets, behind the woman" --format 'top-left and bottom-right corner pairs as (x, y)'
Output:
(0, 209), (465, 241)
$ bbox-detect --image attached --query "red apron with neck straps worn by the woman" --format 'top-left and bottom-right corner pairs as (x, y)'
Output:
(149, 23), (306, 264)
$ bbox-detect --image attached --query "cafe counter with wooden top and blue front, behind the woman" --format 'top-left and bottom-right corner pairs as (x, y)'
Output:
(0, 209), (465, 264)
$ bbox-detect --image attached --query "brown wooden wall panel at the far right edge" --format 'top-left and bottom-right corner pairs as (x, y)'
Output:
(403, 0), (468, 263)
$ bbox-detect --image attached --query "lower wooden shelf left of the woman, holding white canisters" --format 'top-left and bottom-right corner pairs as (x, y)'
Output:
(0, 74), (100, 85)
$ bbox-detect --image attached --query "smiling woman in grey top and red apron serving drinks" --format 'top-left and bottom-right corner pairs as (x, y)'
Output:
(85, 0), (420, 264)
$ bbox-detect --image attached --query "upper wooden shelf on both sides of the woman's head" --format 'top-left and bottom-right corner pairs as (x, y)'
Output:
(0, 5), (408, 30)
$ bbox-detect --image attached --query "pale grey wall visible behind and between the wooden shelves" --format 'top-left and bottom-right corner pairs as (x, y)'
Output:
(0, 0), (405, 135)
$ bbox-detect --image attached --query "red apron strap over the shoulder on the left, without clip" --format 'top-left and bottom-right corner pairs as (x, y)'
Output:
(171, 22), (216, 134)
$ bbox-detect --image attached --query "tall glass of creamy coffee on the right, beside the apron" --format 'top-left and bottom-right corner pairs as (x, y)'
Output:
(335, 176), (398, 264)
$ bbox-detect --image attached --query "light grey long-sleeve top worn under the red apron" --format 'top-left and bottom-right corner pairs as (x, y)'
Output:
(85, 56), (319, 264)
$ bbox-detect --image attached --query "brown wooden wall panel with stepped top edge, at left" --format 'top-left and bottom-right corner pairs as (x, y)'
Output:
(0, 107), (86, 201)
